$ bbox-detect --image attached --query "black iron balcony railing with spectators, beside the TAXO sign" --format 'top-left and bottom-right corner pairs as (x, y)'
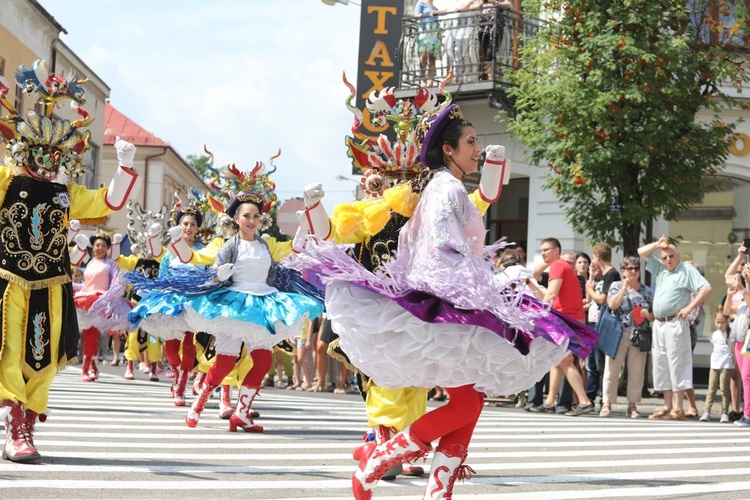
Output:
(399, 6), (541, 92)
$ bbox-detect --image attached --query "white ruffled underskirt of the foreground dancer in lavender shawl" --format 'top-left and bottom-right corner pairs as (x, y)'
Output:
(326, 281), (568, 394)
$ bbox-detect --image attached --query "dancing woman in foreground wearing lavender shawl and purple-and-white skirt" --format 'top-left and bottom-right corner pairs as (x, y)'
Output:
(289, 99), (597, 499)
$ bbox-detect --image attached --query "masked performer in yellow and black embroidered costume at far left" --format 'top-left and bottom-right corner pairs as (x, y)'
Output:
(0, 61), (139, 462)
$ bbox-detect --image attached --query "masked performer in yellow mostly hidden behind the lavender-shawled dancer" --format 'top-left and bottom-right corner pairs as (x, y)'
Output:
(301, 76), (510, 479)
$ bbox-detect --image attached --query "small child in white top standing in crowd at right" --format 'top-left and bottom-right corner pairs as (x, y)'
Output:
(700, 312), (734, 423)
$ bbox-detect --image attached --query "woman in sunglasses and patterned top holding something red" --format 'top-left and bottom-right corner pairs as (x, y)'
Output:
(599, 257), (654, 418)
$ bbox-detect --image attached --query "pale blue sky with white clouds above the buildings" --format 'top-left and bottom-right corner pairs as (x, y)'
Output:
(39, 0), (368, 213)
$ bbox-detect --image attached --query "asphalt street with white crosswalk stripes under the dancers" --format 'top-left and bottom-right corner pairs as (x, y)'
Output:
(0, 365), (750, 499)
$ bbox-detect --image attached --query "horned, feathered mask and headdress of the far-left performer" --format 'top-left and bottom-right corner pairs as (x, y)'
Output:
(0, 60), (92, 182)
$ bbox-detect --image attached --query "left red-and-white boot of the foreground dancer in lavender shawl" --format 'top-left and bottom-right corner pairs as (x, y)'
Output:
(352, 426), (431, 500)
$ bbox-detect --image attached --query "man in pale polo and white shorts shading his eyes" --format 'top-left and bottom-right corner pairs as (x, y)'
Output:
(638, 235), (712, 420)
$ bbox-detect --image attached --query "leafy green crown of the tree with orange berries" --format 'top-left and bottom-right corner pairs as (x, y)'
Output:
(509, 0), (748, 255)
